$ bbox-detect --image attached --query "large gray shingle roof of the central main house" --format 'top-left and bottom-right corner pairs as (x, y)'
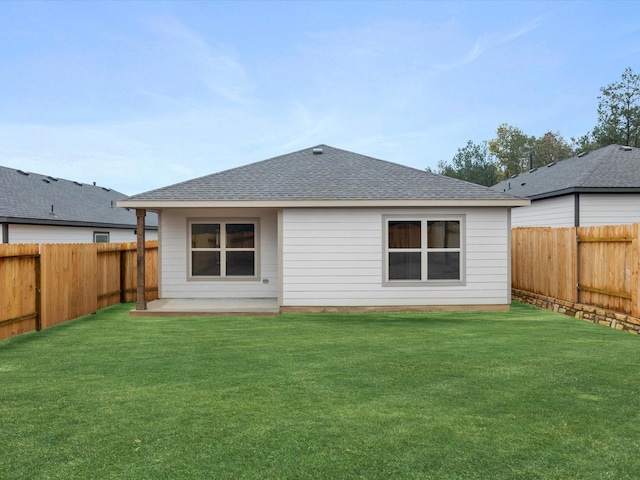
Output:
(130, 145), (513, 201)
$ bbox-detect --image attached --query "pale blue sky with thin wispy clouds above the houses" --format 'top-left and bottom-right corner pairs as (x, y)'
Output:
(0, 0), (640, 194)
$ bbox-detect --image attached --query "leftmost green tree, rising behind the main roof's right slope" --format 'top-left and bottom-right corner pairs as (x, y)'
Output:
(438, 140), (498, 187)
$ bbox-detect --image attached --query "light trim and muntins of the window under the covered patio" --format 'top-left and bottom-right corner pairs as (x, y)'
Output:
(187, 218), (260, 282)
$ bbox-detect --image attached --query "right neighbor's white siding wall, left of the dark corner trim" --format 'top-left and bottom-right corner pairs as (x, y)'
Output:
(511, 195), (582, 228)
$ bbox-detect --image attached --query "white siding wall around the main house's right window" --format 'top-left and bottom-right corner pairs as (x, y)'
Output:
(282, 208), (511, 306)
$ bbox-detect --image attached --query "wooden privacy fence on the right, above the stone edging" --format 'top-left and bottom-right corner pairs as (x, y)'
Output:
(511, 224), (640, 317)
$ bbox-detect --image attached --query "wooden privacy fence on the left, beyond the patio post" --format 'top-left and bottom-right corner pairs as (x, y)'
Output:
(0, 240), (158, 340)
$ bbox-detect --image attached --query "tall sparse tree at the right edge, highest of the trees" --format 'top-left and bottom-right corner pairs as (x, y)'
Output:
(593, 67), (640, 147)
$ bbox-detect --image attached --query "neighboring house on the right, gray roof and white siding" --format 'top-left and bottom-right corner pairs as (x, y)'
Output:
(491, 145), (640, 227)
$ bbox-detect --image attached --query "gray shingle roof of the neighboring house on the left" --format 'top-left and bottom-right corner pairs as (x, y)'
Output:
(0, 167), (158, 228)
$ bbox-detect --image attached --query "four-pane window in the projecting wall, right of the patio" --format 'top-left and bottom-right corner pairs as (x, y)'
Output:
(385, 218), (463, 282)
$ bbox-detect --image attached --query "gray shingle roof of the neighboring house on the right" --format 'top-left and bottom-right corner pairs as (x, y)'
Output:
(491, 145), (640, 199)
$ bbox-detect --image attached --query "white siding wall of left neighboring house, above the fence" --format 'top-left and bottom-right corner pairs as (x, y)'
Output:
(2, 224), (158, 243)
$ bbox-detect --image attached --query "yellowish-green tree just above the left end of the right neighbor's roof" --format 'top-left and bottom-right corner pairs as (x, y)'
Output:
(489, 123), (536, 180)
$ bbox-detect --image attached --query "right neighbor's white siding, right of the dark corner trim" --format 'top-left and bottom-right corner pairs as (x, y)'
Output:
(580, 193), (640, 227)
